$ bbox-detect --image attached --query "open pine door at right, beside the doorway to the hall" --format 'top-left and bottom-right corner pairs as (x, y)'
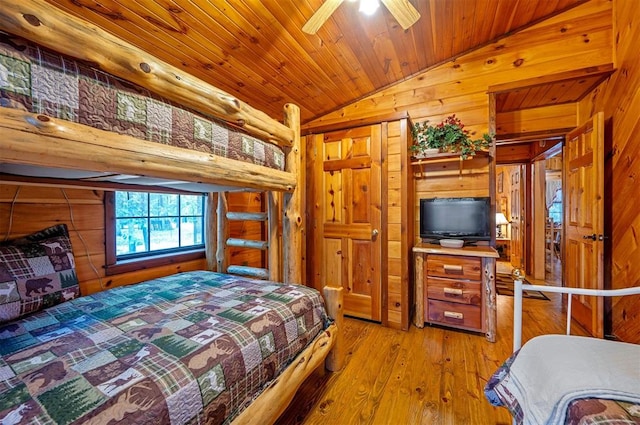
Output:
(563, 112), (604, 338)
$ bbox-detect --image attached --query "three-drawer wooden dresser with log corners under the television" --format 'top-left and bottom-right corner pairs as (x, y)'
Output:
(413, 244), (498, 342)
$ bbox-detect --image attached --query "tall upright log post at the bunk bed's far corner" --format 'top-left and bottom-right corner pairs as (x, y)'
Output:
(282, 103), (306, 283)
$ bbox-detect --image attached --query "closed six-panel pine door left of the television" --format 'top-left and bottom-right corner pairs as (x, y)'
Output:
(313, 125), (382, 321)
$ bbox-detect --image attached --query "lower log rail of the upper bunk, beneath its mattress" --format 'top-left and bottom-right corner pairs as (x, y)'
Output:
(0, 107), (296, 191)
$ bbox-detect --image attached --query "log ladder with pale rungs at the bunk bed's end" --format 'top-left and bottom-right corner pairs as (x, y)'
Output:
(216, 192), (282, 282)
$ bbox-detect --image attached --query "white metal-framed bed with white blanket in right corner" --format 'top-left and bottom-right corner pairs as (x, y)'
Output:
(484, 269), (640, 425)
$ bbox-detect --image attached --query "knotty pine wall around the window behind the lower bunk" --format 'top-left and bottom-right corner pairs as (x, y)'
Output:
(0, 183), (263, 295)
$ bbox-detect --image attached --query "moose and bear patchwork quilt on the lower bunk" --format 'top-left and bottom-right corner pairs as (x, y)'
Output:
(0, 271), (329, 425)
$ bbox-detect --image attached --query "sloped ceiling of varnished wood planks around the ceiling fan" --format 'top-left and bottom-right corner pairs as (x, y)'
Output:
(47, 0), (585, 123)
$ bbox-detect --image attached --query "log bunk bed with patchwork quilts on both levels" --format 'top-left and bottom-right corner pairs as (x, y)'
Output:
(0, 0), (344, 424)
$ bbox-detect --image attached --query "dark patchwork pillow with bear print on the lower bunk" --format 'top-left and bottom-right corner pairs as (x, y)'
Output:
(0, 224), (80, 323)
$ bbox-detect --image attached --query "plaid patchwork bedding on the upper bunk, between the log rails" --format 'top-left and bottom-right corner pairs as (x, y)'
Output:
(0, 32), (284, 170)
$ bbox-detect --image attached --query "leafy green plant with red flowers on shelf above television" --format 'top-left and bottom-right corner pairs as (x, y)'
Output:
(410, 114), (493, 159)
